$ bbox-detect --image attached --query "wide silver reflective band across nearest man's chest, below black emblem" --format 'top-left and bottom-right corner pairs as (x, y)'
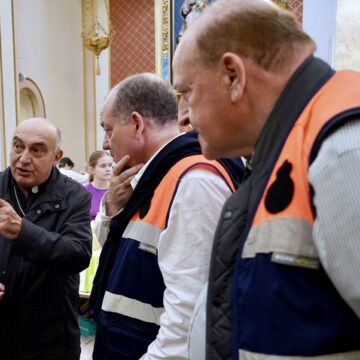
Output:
(242, 218), (318, 258)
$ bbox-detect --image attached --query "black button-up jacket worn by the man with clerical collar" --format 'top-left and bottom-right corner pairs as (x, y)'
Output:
(0, 168), (92, 360)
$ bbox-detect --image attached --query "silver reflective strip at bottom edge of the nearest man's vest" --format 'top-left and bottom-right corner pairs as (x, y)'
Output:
(239, 349), (360, 360)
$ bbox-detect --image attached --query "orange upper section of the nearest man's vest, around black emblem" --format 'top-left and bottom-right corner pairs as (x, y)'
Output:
(253, 71), (360, 226)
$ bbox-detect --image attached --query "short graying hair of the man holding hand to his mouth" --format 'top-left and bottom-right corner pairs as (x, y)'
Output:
(112, 73), (177, 125)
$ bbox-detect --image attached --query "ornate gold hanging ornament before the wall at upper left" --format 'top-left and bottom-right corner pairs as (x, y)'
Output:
(81, 0), (114, 75)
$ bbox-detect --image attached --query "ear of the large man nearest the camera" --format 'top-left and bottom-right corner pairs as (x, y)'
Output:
(221, 52), (246, 103)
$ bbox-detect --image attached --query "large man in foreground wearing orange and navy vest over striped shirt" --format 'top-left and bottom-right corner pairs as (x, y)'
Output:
(173, 0), (360, 360)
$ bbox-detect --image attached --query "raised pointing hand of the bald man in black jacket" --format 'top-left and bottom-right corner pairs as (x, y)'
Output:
(0, 199), (22, 240)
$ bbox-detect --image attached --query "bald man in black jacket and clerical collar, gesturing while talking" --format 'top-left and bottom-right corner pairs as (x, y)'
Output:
(0, 118), (91, 360)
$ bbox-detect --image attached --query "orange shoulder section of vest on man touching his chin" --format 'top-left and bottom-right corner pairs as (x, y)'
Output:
(131, 155), (235, 229)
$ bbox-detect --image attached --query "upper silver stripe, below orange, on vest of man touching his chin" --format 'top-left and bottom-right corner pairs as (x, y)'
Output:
(123, 221), (162, 249)
